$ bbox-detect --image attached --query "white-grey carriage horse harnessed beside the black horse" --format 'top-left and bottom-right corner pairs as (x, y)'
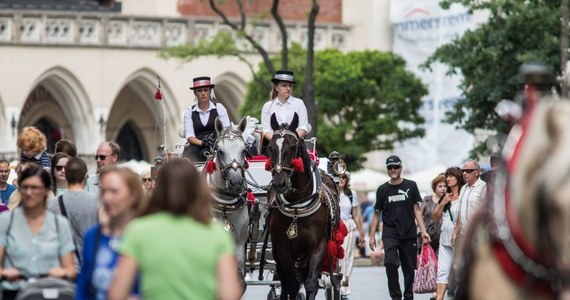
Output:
(203, 118), (249, 277)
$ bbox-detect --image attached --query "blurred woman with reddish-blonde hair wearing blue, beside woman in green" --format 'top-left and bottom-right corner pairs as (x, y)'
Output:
(75, 167), (141, 300)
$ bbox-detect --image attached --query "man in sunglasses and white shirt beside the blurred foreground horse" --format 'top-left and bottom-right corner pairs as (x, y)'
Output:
(451, 159), (487, 245)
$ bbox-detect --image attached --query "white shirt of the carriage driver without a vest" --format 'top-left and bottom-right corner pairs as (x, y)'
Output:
(261, 96), (311, 132)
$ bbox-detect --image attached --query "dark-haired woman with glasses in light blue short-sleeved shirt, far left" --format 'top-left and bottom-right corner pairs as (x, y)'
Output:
(0, 164), (76, 300)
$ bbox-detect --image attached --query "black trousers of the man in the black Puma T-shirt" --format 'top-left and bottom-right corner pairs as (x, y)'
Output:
(382, 238), (417, 300)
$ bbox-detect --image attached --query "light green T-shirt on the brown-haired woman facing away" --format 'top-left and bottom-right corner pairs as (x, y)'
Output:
(120, 213), (235, 300)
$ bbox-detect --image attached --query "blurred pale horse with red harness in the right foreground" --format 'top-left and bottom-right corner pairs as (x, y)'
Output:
(456, 99), (570, 300)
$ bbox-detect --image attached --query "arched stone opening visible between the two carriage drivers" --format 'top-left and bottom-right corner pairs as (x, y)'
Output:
(214, 72), (247, 123)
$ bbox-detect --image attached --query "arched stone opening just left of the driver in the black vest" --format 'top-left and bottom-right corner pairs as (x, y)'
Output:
(105, 68), (181, 162)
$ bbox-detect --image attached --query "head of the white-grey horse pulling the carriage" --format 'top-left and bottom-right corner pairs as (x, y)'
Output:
(214, 117), (247, 195)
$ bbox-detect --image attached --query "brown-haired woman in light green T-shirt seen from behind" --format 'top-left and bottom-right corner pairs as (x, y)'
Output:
(109, 159), (243, 300)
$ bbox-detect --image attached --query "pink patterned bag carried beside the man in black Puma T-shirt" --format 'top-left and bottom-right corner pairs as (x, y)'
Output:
(413, 243), (437, 294)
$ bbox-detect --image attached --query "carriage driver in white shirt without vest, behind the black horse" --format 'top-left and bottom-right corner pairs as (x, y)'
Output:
(261, 71), (311, 155)
